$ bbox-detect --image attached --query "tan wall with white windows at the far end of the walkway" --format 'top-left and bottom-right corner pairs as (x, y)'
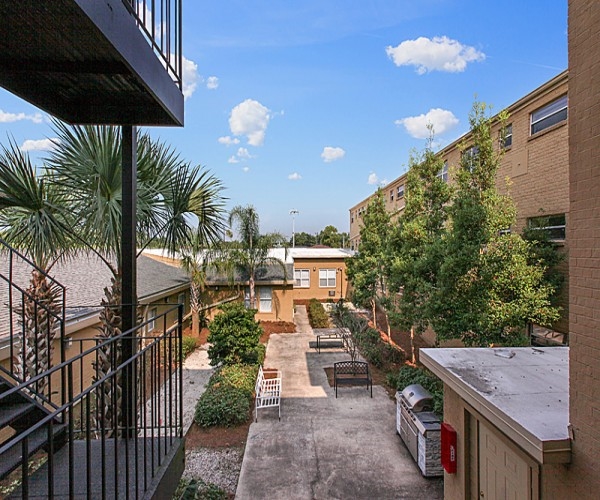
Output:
(294, 258), (348, 301)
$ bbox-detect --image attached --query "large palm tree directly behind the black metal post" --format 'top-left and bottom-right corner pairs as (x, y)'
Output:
(48, 121), (224, 428)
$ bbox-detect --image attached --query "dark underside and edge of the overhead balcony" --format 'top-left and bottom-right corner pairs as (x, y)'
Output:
(0, 0), (183, 126)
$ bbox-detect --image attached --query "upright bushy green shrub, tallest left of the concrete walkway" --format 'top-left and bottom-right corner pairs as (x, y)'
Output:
(208, 302), (263, 366)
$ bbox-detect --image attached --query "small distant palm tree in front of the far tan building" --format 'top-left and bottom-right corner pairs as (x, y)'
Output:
(227, 205), (287, 309)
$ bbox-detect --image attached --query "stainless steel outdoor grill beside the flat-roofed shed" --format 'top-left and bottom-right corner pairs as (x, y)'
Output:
(396, 384), (443, 476)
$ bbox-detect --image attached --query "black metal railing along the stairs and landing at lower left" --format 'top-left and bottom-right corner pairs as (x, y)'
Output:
(0, 305), (183, 498)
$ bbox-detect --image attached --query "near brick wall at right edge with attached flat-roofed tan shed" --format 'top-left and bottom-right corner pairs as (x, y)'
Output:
(420, 0), (600, 500)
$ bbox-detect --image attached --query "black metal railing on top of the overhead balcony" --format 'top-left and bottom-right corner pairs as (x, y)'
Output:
(123, 0), (183, 90)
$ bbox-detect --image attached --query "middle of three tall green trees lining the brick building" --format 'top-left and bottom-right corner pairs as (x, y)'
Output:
(386, 133), (451, 354)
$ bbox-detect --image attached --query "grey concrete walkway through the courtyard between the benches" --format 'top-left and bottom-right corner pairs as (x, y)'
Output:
(236, 306), (443, 500)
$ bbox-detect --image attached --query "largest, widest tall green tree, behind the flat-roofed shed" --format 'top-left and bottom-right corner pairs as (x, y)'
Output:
(430, 103), (558, 346)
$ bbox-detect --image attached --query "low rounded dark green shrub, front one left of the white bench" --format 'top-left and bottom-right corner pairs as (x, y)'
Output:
(194, 384), (252, 427)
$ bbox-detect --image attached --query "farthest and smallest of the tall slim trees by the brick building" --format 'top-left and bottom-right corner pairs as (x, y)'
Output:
(346, 189), (391, 326)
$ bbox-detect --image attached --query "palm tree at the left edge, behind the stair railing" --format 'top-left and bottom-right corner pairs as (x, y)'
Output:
(0, 141), (72, 394)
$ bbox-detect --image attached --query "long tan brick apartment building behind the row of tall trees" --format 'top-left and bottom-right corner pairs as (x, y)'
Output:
(350, 71), (569, 343)
